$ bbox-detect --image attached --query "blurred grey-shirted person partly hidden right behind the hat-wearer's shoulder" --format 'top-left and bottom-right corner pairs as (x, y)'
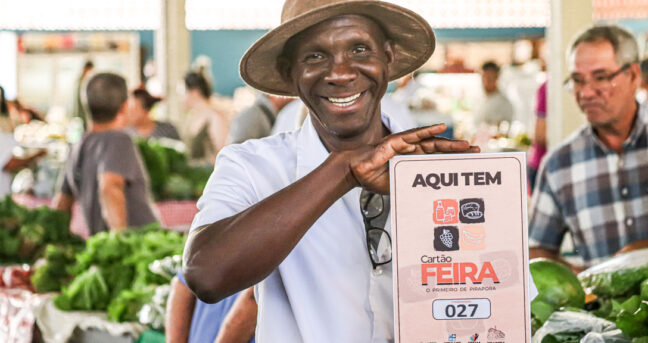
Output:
(227, 93), (294, 144)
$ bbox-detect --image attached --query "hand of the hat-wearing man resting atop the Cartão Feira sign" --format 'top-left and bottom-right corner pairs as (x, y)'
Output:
(341, 124), (479, 194)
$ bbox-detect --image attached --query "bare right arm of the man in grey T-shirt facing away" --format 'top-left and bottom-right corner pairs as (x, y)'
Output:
(99, 172), (128, 231)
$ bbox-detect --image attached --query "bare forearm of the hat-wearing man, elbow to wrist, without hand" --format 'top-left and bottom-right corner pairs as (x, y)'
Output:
(184, 154), (355, 303)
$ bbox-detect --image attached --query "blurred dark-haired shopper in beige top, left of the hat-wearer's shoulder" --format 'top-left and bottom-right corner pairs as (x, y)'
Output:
(185, 72), (229, 163)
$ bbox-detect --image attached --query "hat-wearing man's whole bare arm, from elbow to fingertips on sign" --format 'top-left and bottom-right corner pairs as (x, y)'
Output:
(184, 124), (479, 303)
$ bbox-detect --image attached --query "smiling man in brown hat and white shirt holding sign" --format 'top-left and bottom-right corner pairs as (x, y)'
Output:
(184, 0), (479, 342)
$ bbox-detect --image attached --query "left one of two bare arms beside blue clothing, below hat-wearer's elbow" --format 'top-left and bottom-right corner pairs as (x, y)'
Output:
(164, 276), (196, 343)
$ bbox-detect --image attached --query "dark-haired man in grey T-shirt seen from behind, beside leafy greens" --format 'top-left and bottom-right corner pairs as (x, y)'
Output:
(54, 73), (156, 234)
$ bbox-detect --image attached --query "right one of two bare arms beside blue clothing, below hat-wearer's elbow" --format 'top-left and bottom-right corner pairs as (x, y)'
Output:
(214, 287), (257, 343)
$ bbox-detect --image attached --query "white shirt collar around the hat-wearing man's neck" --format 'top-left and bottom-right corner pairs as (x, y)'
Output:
(297, 112), (403, 179)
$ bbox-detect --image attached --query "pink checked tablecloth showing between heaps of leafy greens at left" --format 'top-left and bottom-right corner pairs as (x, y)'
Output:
(12, 194), (198, 238)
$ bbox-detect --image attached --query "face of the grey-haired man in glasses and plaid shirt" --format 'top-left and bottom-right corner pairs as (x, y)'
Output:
(570, 40), (640, 127)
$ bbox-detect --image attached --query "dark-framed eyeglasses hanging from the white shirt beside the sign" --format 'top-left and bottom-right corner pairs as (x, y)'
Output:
(360, 189), (392, 269)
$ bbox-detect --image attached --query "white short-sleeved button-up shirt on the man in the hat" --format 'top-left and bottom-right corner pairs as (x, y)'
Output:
(192, 114), (404, 343)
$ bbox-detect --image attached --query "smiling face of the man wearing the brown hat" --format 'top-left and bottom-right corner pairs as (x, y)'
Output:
(283, 15), (393, 149)
